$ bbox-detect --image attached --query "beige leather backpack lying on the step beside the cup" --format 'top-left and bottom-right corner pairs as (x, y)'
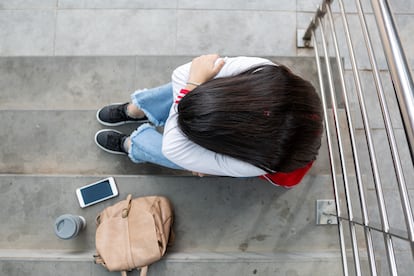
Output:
(94, 195), (173, 276)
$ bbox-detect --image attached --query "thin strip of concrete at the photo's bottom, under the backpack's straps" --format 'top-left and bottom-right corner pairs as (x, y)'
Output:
(0, 253), (340, 276)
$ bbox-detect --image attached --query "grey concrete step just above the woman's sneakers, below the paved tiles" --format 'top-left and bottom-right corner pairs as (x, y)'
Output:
(0, 56), (318, 110)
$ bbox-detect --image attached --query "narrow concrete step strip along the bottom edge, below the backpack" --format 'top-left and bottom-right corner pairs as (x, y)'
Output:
(0, 250), (341, 276)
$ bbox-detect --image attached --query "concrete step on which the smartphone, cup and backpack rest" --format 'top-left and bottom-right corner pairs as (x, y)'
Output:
(0, 175), (338, 252)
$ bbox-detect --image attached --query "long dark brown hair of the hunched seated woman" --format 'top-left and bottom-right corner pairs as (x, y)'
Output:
(178, 65), (323, 172)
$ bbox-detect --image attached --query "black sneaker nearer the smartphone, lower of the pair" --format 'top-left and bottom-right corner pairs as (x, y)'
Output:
(95, 129), (128, 155)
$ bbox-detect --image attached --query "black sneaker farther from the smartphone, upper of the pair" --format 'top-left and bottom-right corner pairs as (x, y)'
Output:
(96, 103), (148, 126)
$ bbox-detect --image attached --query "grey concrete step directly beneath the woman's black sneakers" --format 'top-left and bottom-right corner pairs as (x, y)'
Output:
(0, 110), (182, 175)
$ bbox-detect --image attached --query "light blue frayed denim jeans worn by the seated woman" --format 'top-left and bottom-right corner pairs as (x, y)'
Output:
(128, 83), (183, 170)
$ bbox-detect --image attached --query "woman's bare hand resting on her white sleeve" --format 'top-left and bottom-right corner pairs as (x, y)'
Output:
(186, 54), (224, 90)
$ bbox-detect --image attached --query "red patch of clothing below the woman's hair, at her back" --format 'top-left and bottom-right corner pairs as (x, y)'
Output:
(259, 161), (313, 187)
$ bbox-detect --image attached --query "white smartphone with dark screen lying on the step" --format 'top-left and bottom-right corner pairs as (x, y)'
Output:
(76, 177), (118, 208)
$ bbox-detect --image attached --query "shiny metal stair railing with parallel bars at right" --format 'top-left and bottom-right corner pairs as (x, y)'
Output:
(303, 0), (414, 275)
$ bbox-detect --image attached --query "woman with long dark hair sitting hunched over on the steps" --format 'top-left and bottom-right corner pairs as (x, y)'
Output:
(95, 55), (323, 186)
